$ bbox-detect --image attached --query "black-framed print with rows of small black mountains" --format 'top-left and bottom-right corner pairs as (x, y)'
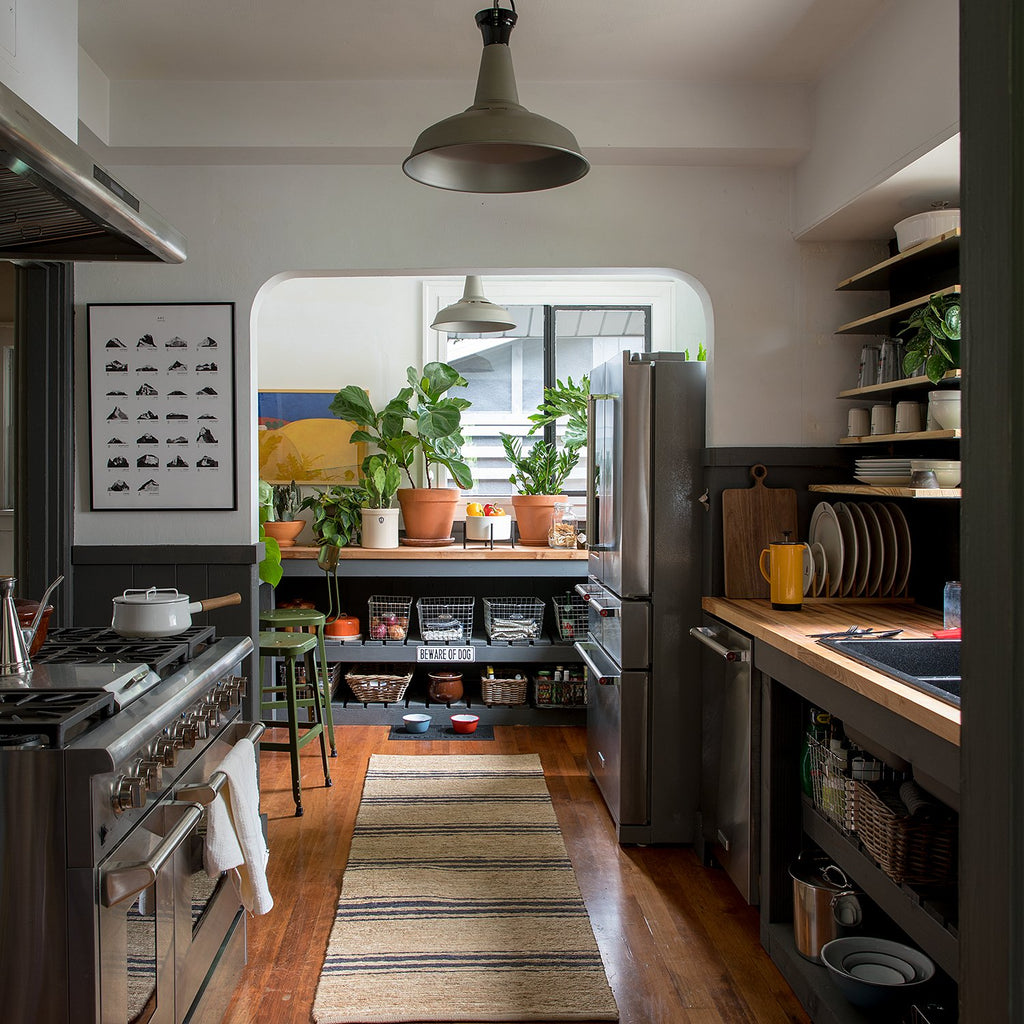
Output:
(87, 302), (238, 511)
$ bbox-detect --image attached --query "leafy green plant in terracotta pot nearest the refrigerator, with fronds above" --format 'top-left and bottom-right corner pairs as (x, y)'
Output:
(501, 375), (590, 547)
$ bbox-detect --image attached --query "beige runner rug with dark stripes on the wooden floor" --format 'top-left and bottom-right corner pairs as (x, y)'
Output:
(313, 754), (618, 1024)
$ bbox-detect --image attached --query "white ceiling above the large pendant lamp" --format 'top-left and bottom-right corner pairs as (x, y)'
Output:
(79, 0), (892, 82)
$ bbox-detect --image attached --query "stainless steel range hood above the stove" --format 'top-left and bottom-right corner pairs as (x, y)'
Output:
(0, 83), (185, 263)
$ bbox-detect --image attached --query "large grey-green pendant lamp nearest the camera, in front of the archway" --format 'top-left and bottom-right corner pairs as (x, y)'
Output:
(401, 0), (590, 193)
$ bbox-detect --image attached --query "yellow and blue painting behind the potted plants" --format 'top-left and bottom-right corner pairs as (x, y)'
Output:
(258, 391), (366, 484)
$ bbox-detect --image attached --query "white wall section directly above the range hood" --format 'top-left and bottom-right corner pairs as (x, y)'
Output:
(0, 0), (78, 139)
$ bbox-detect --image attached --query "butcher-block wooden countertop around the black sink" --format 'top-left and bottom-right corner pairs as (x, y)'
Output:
(701, 597), (961, 745)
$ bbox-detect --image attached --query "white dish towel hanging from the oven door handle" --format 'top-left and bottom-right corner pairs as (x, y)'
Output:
(203, 739), (273, 914)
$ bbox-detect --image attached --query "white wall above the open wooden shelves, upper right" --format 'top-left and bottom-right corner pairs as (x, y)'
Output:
(793, 0), (959, 237)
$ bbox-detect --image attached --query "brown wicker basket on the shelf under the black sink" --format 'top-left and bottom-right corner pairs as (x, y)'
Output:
(853, 780), (957, 886)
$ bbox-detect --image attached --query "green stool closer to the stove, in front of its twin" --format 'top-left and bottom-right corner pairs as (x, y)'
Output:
(259, 630), (333, 817)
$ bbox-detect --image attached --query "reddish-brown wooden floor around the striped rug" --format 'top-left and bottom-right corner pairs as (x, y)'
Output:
(224, 726), (809, 1024)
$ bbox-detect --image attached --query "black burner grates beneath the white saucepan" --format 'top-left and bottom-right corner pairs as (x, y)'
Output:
(32, 626), (216, 675)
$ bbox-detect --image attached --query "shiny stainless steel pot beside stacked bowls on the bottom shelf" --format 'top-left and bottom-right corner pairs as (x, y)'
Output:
(790, 854), (862, 964)
